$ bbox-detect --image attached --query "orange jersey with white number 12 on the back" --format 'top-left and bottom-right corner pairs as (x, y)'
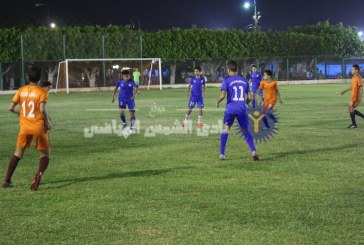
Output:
(13, 85), (48, 134)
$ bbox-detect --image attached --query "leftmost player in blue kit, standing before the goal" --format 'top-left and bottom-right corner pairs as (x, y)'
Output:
(111, 70), (138, 130)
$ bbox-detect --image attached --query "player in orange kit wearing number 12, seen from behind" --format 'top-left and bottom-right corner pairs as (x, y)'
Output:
(2, 66), (52, 191)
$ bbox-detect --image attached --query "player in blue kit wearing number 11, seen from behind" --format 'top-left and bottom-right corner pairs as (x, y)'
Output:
(216, 61), (259, 161)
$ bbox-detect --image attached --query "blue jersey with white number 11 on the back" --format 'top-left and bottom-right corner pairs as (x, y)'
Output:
(221, 75), (250, 110)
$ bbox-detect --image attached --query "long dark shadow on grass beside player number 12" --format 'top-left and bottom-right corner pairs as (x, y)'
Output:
(44, 167), (192, 189)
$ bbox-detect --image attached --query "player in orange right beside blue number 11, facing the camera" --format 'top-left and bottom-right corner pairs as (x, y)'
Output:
(254, 70), (283, 129)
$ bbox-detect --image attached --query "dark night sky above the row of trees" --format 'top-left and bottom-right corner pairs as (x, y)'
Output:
(0, 0), (364, 31)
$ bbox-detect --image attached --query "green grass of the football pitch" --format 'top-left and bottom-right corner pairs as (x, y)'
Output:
(0, 85), (364, 244)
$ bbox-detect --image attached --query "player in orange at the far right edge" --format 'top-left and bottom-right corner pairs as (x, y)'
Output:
(341, 65), (364, 128)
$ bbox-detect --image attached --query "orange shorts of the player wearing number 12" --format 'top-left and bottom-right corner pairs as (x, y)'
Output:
(16, 130), (49, 150)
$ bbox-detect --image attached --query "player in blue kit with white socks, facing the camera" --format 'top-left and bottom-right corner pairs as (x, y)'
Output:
(183, 66), (206, 127)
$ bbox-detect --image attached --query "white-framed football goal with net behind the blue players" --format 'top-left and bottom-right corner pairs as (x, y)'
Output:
(56, 58), (162, 93)
